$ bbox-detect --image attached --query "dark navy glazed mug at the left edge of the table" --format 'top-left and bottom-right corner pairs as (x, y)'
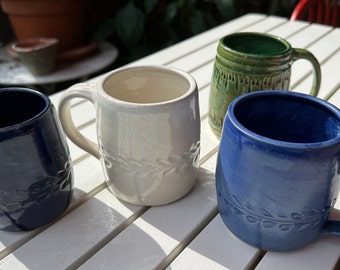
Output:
(0, 87), (73, 231)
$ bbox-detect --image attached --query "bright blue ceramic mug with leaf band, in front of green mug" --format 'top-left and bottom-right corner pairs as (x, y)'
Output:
(216, 90), (340, 251)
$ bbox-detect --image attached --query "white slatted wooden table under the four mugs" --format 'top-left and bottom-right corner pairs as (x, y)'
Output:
(0, 14), (340, 270)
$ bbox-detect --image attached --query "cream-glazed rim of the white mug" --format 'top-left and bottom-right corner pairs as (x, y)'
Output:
(97, 65), (198, 108)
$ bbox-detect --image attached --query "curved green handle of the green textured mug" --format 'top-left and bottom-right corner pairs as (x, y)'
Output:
(293, 48), (321, 96)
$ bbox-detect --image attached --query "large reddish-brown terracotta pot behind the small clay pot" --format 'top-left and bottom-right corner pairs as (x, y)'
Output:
(1, 0), (85, 50)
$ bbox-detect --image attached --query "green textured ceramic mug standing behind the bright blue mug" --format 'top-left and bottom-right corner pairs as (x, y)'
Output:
(209, 32), (321, 137)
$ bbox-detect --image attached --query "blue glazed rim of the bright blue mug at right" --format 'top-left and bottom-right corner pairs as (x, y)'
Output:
(226, 90), (340, 149)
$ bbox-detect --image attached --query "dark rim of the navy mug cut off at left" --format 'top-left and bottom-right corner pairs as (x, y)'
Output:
(0, 86), (51, 132)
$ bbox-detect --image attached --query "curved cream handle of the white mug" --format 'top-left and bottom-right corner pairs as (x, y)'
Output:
(59, 83), (99, 159)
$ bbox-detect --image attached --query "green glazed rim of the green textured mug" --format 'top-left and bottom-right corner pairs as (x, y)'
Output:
(219, 32), (292, 58)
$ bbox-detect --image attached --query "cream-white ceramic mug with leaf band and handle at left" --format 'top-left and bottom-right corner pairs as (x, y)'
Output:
(59, 66), (200, 205)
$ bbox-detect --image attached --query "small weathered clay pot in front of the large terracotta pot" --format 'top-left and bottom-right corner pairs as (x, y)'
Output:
(11, 37), (59, 75)
